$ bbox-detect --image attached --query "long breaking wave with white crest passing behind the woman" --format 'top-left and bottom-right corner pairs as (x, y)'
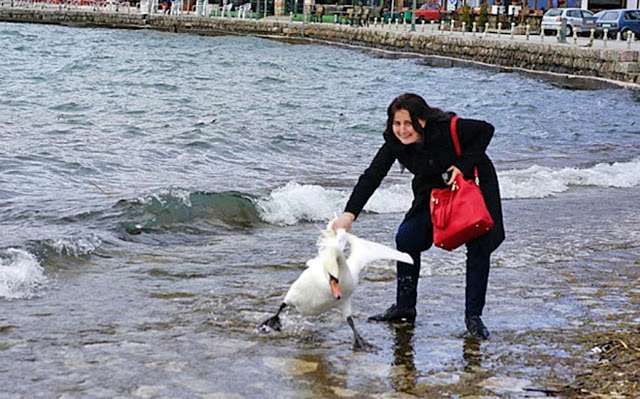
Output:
(100, 160), (640, 231)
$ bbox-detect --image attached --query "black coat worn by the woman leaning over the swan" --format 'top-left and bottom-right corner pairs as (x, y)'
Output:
(345, 118), (504, 251)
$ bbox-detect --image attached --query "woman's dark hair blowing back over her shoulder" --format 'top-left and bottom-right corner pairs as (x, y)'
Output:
(384, 93), (455, 141)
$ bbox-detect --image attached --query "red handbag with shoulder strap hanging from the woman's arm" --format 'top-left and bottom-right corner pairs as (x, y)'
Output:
(430, 116), (493, 251)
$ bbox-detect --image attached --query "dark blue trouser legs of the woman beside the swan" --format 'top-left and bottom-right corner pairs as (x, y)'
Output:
(396, 208), (491, 316)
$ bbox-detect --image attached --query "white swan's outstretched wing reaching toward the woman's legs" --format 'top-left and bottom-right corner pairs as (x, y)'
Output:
(346, 233), (413, 281)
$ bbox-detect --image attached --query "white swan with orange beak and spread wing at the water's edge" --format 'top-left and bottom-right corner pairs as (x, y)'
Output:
(259, 227), (413, 349)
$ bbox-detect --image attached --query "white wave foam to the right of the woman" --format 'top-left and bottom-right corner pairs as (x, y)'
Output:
(498, 159), (640, 199)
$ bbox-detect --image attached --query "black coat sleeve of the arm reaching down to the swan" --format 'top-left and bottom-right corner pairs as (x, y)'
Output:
(344, 143), (396, 218)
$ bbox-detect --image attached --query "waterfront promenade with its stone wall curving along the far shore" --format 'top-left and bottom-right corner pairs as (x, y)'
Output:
(0, 4), (640, 89)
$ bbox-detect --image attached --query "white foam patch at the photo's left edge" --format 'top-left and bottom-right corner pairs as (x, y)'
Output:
(0, 248), (47, 299)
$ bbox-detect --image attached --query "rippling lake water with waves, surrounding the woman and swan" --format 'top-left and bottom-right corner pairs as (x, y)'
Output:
(0, 24), (640, 398)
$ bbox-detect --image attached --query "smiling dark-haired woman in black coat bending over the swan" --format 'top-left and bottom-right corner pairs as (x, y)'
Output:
(332, 94), (504, 339)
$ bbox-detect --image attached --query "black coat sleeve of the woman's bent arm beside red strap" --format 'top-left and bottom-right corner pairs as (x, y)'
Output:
(455, 119), (494, 176)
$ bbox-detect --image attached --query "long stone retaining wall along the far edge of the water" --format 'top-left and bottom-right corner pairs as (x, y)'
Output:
(0, 8), (640, 88)
